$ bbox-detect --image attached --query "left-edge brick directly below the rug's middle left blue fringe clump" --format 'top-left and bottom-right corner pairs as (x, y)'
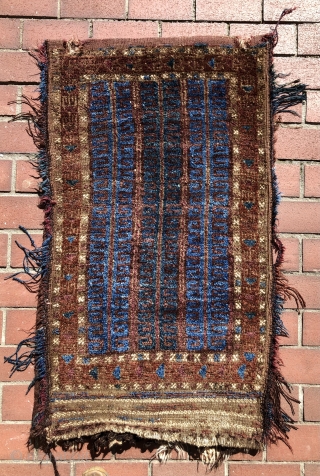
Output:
(0, 273), (36, 307)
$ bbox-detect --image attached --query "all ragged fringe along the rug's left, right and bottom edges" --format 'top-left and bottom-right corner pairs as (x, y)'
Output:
(5, 9), (306, 476)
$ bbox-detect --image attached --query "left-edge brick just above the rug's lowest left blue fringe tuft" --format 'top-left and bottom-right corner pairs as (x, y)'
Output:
(6, 309), (36, 345)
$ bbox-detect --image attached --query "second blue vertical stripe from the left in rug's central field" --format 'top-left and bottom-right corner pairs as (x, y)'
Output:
(110, 82), (135, 352)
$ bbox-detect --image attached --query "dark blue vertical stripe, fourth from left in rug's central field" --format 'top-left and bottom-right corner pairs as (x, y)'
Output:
(159, 80), (182, 350)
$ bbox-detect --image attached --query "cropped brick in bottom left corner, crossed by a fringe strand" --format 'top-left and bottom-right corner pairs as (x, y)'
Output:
(0, 464), (70, 476)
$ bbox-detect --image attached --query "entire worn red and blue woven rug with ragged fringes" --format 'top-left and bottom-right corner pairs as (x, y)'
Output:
(7, 28), (304, 466)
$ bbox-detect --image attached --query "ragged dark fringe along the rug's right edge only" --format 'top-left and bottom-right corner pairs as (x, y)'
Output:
(263, 8), (306, 449)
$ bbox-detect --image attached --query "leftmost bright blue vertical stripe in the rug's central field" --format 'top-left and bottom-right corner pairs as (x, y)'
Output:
(88, 82), (113, 354)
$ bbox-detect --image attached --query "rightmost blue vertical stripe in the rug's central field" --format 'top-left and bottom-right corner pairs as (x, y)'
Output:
(207, 80), (230, 351)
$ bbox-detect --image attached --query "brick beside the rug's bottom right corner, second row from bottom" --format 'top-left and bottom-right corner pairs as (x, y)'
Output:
(267, 425), (320, 462)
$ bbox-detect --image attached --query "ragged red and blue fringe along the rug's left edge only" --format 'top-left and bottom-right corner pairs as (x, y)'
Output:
(5, 41), (54, 464)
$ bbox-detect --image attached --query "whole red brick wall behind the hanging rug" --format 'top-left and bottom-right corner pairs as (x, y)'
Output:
(0, 0), (320, 476)
